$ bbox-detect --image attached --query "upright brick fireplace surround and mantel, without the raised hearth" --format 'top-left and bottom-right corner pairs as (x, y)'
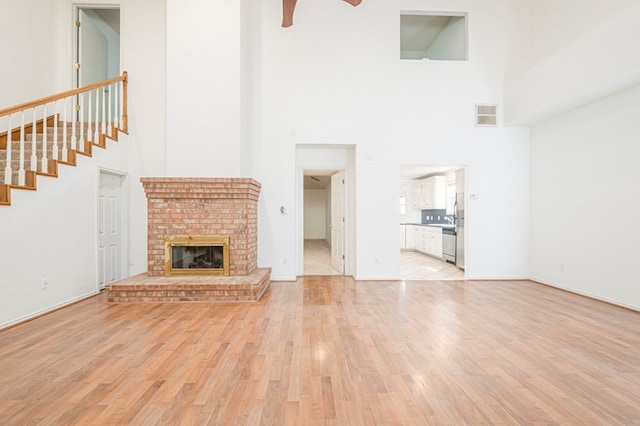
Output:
(140, 177), (260, 276)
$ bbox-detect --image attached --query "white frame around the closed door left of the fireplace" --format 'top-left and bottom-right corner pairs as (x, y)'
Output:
(94, 167), (130, 292)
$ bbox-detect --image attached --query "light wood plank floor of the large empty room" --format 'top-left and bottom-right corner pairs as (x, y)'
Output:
(0, 276), (640, 425)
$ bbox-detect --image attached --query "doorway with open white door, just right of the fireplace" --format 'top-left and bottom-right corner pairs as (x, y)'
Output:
(303, 170), (345, 275)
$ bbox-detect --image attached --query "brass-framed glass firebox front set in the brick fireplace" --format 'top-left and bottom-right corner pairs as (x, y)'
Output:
(165, 236), (229, 276)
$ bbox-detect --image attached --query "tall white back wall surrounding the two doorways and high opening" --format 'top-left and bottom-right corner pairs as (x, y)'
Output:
(253, 1), (529, 279)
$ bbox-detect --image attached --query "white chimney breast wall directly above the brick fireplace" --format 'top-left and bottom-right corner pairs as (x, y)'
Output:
(167, 0), (242, 176)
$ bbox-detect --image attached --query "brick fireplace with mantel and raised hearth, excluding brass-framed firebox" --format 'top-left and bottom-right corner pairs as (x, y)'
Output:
(108, 177), (271, 302)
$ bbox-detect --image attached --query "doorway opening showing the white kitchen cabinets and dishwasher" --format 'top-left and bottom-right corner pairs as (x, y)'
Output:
(399, 165), (466, 280)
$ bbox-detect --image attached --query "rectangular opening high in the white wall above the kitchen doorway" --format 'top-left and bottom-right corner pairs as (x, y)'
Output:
(400, 11), (468, 61)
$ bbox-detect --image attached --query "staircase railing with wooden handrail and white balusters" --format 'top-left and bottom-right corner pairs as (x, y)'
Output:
(0, 71), (129, 206)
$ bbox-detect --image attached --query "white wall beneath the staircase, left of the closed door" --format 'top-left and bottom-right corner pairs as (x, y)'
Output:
(0, 131), (135, 328)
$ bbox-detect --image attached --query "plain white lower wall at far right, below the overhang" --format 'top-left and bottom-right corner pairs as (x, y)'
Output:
(531, 86), (640, 309)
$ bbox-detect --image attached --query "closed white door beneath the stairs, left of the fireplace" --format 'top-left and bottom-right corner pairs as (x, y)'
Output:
(98, 173), (122, 290)
